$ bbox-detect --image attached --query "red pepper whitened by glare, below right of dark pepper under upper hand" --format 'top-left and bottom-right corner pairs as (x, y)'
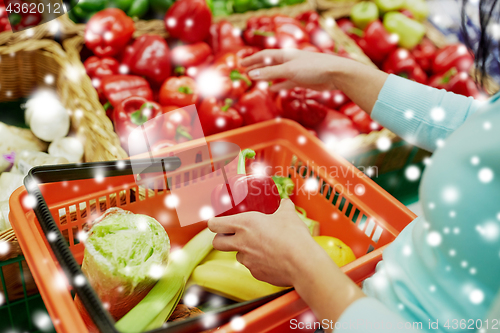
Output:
(316, 110), (359, 146)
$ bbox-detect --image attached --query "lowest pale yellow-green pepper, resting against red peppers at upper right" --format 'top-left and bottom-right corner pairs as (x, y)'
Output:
(384, 12), (425, 50)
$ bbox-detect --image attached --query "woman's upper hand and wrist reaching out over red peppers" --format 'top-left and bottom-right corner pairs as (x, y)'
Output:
(241, 49), (388, 114)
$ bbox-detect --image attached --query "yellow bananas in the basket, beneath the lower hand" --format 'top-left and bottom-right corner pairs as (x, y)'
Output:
(189, 250), (286, 302)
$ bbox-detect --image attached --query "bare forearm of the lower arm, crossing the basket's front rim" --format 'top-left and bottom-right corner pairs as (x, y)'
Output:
(294, 243), (365, 330)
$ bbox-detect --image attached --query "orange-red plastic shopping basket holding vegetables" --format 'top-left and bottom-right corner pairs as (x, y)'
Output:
(10, 120), (415, 332)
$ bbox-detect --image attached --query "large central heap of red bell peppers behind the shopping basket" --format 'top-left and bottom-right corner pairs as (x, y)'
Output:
(83, 5), (380, 156)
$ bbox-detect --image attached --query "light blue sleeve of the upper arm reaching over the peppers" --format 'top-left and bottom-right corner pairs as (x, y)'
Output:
(371, 75), (481, 151)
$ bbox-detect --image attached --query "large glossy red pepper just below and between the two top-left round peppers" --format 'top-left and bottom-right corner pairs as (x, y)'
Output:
(122, 34), (170, 86)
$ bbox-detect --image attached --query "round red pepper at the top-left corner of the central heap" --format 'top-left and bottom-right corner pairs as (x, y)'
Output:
(85, 8), (135, 57)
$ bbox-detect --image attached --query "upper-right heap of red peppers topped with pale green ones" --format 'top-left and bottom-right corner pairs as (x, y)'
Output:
(337, 0), (485, 99)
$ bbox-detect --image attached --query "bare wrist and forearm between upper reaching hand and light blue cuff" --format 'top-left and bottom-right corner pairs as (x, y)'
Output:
(332, 59), (389, 114)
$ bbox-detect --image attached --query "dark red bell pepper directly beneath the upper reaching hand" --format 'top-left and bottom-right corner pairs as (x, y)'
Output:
(278, 87), (329, 127)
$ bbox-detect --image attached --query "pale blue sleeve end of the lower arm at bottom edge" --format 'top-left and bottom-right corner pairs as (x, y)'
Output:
(333, 297), (428, 333)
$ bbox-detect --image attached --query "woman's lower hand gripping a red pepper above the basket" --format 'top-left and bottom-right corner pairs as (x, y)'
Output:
(208, 199), (324, 286)
